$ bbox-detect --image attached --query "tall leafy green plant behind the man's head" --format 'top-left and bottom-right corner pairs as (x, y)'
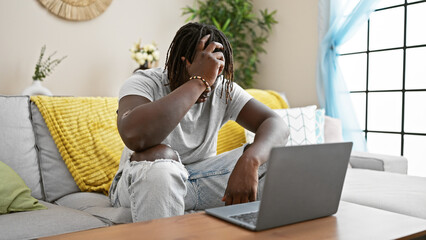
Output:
(183, 0), (278, 88)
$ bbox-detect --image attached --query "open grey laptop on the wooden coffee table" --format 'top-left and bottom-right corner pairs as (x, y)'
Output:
(206, 142), (352, 231)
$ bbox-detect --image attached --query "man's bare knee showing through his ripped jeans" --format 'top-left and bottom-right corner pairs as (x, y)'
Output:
(130, 144), (179, 161)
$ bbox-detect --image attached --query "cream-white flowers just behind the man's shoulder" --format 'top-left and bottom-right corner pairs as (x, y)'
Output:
(130, 39), (160, 71)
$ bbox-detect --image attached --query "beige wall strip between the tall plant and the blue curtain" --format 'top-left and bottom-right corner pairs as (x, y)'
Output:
(255, 0), (318, 107)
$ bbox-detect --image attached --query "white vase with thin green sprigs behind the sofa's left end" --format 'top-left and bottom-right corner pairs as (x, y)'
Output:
(22, 45), (66, 96)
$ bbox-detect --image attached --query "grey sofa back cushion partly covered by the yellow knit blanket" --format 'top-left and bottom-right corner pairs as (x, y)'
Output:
(31, 102), (80, 202)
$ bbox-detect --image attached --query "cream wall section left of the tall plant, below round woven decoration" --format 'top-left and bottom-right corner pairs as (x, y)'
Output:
(0, 0), (192, 96)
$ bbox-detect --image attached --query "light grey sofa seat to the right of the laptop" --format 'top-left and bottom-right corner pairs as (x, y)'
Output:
(342, 168), (426, 219)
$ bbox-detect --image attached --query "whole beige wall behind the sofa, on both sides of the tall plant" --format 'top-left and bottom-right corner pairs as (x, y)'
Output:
(0, 0), (317, 106)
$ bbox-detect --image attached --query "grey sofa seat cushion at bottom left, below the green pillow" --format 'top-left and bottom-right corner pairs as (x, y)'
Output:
(0, 201), (107, 239)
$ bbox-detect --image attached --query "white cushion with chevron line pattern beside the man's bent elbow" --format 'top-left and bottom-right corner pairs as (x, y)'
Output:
(245, 105), (317, 146)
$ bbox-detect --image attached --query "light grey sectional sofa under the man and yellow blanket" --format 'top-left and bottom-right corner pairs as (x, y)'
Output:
(0, 95), (426, 239)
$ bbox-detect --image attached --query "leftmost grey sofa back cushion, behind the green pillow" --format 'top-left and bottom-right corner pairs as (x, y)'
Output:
(0, 96), (44, 199)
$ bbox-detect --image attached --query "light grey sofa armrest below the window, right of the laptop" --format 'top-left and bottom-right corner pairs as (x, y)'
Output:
(350, 152), (408, 174)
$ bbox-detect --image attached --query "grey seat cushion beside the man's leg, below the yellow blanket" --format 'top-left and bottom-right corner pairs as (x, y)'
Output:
(55, 192), (132, 225)
